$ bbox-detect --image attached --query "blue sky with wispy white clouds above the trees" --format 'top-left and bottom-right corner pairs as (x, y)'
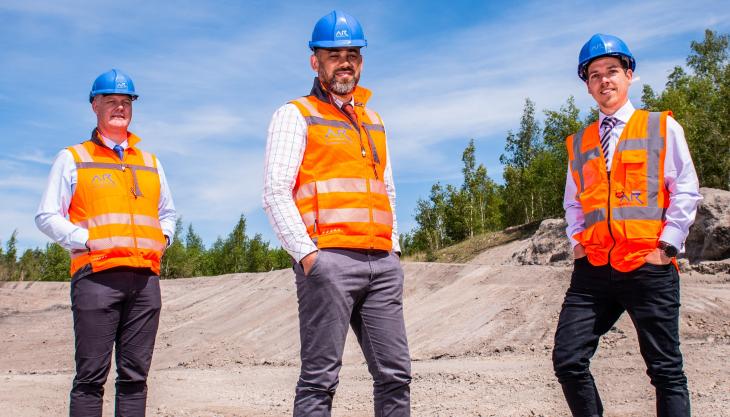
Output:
(0, 0), (730, 248)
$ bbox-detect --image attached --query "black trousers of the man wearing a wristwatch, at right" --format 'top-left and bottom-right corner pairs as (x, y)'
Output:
(553, 257), (690, 417)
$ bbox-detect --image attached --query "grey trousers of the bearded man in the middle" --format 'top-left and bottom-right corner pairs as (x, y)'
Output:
(294, 249), (411, 417)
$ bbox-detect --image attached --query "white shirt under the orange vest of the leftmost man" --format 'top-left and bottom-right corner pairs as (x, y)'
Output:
(35, 136), (177, 250)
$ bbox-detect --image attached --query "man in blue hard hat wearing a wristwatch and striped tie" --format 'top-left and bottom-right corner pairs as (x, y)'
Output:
(553, 34), (702, 417)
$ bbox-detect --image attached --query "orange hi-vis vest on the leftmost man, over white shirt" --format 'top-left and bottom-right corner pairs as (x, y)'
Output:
(67, 129), (166, 276)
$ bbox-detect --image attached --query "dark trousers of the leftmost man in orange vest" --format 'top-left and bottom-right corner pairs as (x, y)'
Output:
(70, 268), (161, 417)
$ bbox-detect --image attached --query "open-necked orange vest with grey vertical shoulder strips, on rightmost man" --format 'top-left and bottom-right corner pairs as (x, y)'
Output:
(566, 110), (676, 272)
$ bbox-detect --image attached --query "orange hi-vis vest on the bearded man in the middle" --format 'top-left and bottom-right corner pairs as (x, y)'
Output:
(291, 79), (393, 251)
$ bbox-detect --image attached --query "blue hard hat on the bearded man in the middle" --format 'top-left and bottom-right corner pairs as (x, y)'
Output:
(309, 10), (368, 50)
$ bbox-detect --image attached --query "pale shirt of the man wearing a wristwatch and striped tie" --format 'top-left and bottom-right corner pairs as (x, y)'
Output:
(563, 101), (702, 251)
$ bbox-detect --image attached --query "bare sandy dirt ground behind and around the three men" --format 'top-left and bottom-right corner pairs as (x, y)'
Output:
(0, 242), (730, 417)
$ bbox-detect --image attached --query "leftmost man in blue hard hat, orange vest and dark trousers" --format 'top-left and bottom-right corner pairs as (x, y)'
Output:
(35, 69), (176, 417)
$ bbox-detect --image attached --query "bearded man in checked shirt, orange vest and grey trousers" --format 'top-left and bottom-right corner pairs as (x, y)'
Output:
(263, 10), (411, 417)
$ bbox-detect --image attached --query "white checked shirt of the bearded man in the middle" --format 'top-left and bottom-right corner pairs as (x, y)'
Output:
(263, 103), (400, 262)
